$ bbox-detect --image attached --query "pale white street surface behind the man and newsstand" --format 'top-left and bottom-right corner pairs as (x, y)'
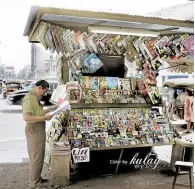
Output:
(0, 96), (172, 163)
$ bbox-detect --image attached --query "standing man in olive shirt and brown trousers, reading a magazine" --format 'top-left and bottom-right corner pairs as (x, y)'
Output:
(22, 80), (57, 189)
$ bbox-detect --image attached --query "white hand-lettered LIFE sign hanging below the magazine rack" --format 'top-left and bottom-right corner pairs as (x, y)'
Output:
(72, 148), (90, 163)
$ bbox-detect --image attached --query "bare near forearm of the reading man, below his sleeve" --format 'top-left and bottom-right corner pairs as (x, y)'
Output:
(24, 113), (53, 123)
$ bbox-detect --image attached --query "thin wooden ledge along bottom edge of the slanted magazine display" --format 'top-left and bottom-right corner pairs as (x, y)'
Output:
(90, 142), (174, 151)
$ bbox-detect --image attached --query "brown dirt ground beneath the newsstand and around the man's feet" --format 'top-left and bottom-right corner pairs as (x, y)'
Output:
(0, 163), (189, 189)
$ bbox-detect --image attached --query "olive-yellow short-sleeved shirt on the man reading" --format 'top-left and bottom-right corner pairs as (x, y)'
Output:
(22, 91), (44, 124)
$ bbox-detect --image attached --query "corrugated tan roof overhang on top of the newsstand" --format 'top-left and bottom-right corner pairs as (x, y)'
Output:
(24, 6), (194, 42)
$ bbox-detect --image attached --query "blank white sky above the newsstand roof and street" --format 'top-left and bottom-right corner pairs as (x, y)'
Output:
(0, 0), (190, 71)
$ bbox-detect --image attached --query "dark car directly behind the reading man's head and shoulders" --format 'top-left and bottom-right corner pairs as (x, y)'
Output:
(7, 81), (58, 105)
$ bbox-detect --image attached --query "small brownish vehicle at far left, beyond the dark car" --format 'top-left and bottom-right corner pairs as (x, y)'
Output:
(3, 81), (22, 99)
